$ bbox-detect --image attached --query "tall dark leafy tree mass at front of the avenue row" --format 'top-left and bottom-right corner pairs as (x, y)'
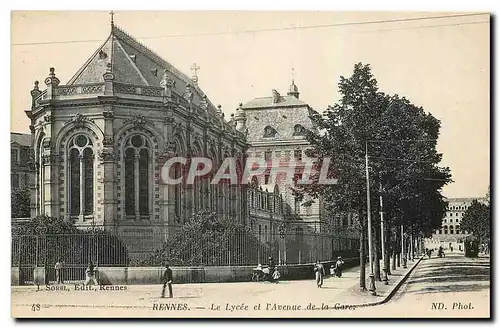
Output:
(296, 63), (451, 290)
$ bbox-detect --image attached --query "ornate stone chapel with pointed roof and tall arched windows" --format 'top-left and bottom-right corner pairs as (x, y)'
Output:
(26, 23), (247, 252)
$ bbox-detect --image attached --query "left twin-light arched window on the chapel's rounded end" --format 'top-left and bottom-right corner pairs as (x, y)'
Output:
(68, 134), (94, 217)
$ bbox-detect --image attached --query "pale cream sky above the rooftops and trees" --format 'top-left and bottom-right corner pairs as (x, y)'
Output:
(11, 11), (490, 197)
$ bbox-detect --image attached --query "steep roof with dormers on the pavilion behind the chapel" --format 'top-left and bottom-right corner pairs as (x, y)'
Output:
(242, 96), (315, 143)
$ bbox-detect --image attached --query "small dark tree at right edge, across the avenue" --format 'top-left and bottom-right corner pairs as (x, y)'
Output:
(460, 200), (491, 243)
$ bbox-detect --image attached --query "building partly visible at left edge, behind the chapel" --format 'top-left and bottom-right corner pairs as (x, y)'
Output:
(10, 132), (33, 189)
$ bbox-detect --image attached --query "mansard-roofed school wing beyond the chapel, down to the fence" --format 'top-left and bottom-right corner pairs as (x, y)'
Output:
(240, 80), (357, 258)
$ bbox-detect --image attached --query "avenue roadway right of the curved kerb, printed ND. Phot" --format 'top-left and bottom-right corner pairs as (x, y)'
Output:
(358, 254), (490, 317)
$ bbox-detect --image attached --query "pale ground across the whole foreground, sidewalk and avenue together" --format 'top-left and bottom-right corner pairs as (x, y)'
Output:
(12, 256), (489, 317)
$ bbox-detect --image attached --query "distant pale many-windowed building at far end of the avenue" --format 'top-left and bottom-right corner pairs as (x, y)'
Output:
(424, 198), (486, 252)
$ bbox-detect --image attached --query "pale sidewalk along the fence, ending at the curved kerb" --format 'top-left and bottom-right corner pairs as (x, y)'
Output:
(11, 259), (424, 317)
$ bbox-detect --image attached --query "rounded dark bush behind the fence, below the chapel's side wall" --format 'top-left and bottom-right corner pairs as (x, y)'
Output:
(143, 211), (266, 266)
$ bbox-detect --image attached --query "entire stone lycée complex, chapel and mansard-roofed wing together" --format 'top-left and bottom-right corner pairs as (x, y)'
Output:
(26, 22), (357, 263)
